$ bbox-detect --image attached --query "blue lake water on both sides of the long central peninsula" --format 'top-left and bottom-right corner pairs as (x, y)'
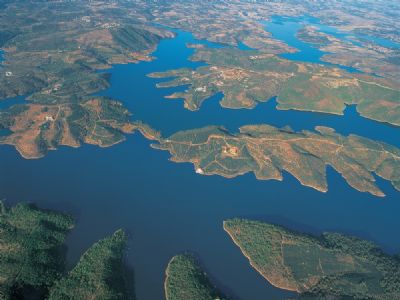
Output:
(0, 18), (400, 300)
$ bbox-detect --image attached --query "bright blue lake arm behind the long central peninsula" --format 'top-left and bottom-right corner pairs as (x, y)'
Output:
(100, 31), (400, 147)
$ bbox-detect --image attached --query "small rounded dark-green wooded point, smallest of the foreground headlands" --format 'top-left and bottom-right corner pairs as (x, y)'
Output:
(165, 254), (224, 300)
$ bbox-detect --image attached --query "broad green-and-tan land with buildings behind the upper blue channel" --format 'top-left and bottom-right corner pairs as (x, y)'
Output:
(149, 47), (400, 125)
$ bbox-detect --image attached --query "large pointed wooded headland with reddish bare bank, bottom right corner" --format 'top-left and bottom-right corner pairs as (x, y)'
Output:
(224, 219), (400, 299)
